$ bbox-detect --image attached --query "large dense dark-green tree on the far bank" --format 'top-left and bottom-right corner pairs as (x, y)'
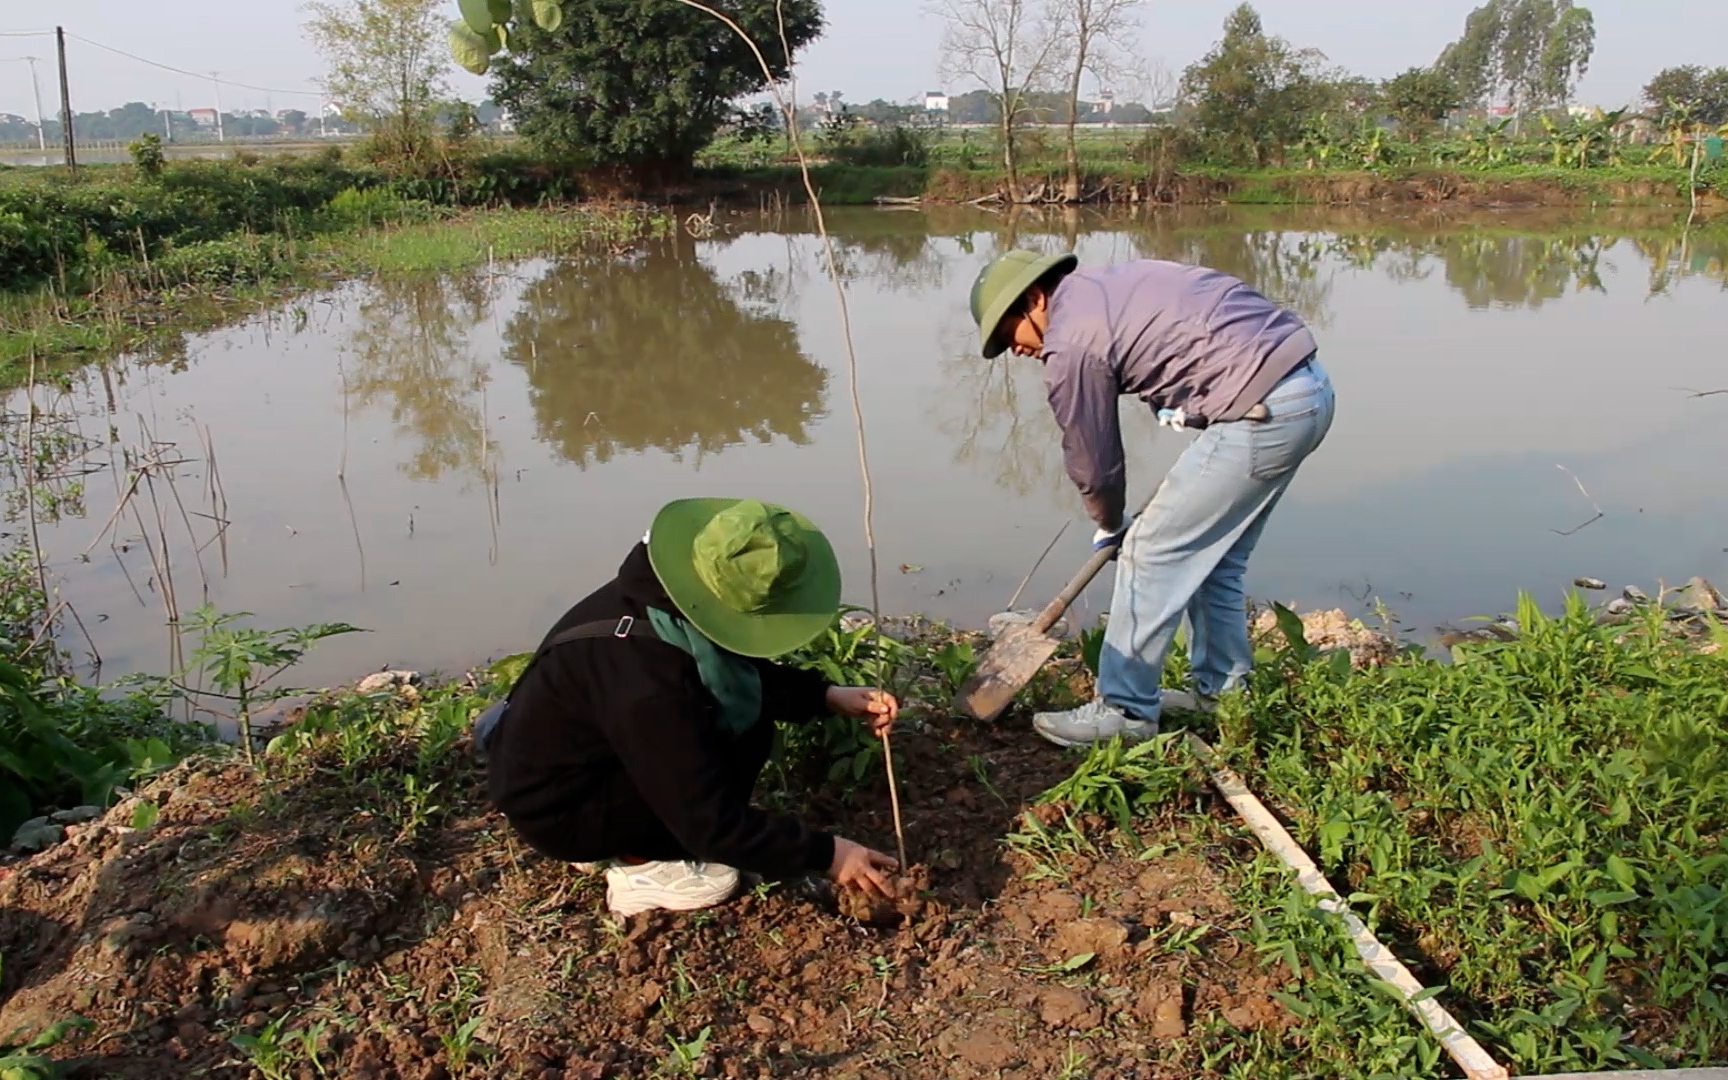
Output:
(492, 0), (823, 181)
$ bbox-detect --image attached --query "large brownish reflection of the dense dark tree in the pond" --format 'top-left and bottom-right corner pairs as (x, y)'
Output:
(505, 238), (828, 467)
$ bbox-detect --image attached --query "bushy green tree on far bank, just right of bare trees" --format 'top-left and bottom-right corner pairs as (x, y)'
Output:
(1182, 3), (1337, 164)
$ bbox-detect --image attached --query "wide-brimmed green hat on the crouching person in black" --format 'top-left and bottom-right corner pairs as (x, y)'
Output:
(648, 499), (840, 658)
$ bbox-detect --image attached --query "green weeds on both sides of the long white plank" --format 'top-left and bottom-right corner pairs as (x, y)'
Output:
(1007, 598), (1728, 1078)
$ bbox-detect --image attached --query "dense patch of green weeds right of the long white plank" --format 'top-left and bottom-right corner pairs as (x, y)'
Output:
(1225, 598), (1728, 1071)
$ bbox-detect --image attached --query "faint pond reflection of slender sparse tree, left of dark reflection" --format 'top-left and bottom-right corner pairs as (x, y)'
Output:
(344, 273), (492, 480)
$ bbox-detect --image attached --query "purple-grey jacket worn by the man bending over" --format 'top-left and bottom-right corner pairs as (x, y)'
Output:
(1044, 259), (1318, 529)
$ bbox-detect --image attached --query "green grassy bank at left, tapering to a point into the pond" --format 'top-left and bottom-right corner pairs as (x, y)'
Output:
(0, 161), (674, 376)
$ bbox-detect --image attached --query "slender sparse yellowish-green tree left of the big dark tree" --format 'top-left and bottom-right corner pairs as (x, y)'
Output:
(306, 0), (449, 159)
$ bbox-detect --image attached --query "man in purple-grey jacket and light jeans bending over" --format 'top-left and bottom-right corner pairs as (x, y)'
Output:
(971, 251), (1334, 746)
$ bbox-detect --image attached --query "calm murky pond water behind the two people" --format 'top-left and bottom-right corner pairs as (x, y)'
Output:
(7, 209), (1728, 683)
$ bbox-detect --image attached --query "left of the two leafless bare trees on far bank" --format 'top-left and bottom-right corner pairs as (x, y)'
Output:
(930, 0), (1068, 200)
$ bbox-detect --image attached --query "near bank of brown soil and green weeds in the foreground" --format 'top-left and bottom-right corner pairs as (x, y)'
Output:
(0, 573), (1728, 1080)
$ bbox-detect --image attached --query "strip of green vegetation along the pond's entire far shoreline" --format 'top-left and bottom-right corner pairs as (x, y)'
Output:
(0, 150), (1723, 374)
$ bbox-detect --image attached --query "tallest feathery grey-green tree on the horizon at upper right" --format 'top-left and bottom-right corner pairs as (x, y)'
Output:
(1436, 0), (1597, 112)
